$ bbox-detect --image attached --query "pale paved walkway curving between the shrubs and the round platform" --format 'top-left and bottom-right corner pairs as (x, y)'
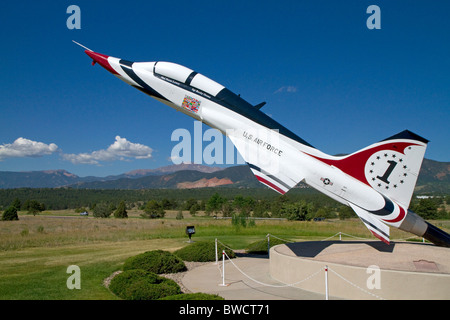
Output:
(182, 256), (332, 300)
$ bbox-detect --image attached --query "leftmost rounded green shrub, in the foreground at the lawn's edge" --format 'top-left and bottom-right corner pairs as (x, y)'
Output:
(109, 269), (181, 300)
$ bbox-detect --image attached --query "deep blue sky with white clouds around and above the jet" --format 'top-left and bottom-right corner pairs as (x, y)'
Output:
(0, 0), (450, 176)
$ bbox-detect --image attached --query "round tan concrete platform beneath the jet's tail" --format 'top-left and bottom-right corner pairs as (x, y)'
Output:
(269, 241), (450, 300)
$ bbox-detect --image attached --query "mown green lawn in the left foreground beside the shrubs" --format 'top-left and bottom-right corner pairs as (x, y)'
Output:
(0, 239), (185, 300)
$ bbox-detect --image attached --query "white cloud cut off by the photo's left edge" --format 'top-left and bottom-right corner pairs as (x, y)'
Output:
(0, 137), (58, 161)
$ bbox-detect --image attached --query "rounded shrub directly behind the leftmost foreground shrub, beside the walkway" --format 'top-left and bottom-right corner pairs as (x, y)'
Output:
(123, 250), (187, 274)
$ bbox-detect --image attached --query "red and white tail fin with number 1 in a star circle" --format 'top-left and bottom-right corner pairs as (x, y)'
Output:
(310, 130), (428, 208)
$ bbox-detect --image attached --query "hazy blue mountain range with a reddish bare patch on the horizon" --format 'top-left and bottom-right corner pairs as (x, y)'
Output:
(0, 159), (450, 194)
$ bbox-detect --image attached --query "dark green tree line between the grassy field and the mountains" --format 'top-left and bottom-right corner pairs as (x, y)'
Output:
(0, 188), (450, 221)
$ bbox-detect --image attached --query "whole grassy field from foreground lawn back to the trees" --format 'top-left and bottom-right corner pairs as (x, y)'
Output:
(0, 210), (450, 300)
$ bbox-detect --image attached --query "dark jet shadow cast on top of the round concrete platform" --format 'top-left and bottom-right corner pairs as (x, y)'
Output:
(286, 240), (395, 258)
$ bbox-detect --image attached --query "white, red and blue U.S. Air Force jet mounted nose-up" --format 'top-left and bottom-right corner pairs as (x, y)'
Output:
(75, 42), (450, 247)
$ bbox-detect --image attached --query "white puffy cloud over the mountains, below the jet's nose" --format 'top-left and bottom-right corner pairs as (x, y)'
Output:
(62, 136), (153, 164)
